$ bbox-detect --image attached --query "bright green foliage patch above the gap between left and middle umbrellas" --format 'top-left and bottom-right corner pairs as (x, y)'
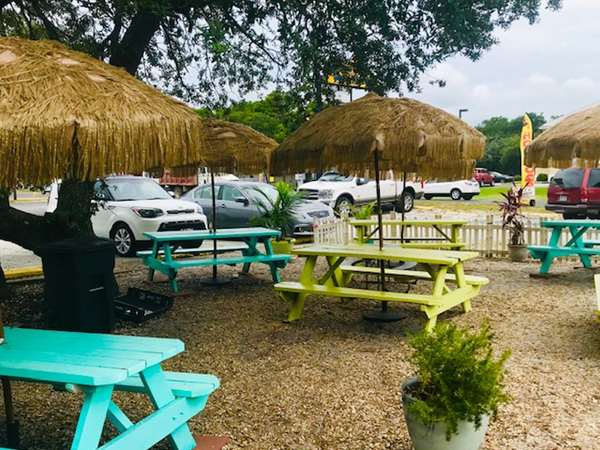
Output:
(198, 90), (314, 142)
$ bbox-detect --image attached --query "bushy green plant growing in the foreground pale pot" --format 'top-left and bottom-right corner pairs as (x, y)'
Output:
(408, 324), (510, 440)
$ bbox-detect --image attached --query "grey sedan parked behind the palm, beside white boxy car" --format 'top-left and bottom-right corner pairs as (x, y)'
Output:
(182, 181), (333, 237)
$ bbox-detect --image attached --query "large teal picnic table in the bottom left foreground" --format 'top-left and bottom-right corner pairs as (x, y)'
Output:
(0, 327), (219, 450)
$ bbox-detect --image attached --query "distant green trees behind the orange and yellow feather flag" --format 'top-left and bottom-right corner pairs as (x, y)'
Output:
(477, 113), (546, 175)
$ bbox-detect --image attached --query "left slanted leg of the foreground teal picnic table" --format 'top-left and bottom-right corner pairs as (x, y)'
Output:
(71, 385), (113, 450)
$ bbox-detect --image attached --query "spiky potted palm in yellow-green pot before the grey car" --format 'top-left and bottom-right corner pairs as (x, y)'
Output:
(252, 181), (303, 254)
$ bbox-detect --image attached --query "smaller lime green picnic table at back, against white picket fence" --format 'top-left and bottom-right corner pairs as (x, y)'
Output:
(350, 219), (467, 250)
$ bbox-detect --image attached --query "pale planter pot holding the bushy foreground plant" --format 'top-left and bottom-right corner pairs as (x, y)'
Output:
(402, 378), (490, 450)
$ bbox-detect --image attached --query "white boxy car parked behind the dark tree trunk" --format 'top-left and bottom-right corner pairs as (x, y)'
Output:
(47, 176), (207, 256)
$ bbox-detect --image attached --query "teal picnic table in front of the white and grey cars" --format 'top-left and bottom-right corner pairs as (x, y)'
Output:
(138, 227), (291, 292)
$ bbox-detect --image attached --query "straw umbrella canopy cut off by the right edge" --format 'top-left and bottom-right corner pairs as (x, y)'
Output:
(525, 105), (600, 168)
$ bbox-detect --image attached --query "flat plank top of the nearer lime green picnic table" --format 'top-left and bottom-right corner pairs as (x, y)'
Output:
(292, 244), (479, 266)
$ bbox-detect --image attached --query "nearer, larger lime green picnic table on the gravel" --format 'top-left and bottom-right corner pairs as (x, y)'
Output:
(275, 244), (488, 331)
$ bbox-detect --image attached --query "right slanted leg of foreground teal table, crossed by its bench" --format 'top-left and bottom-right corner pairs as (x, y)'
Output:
(140, 364), (196, 450)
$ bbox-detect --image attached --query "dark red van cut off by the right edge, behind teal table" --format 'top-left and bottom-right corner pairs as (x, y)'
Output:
(546, 168), (600, 219)
